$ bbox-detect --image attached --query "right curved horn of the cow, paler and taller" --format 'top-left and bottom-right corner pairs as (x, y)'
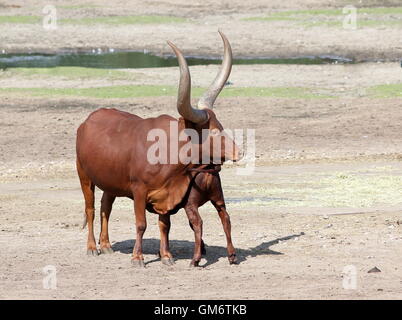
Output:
(198, 30), (232, 109)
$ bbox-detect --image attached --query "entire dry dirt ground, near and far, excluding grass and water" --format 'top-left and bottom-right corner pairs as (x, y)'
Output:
(0, 0), (402, 299)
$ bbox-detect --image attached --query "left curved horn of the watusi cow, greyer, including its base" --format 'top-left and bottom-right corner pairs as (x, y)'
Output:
(167, 41), (208, 123)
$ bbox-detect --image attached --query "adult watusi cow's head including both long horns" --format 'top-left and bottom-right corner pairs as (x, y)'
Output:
(168, 31), (240, 163)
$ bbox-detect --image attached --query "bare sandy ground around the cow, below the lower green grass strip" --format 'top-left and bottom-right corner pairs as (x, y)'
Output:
(0, 98), (402, 299)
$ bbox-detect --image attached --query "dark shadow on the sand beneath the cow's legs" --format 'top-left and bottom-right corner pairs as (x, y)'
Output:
(112, 232), (304, 267)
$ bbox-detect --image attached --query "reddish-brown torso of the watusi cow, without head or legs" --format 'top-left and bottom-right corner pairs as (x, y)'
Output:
(77, 109), (193, 214)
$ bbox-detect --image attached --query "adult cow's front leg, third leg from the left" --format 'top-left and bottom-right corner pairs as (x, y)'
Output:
(131, 190), (147, 267)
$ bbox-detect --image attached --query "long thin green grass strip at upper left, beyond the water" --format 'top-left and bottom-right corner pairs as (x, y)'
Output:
(60, 15), (187, 25)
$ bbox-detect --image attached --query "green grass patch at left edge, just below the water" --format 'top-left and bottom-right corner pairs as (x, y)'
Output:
(0, 67), (134, 80)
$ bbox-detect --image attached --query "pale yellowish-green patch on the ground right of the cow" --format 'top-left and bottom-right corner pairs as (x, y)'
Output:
(234, 171), (402, 208)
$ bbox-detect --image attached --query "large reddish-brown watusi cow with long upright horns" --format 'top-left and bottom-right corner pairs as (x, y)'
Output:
(76, 32), (239, 267)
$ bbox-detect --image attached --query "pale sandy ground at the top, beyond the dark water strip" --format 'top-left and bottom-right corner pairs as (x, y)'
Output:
(0, 0), (402, 60)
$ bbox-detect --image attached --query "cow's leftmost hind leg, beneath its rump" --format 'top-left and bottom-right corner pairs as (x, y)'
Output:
(77, 161), (98, 256)
